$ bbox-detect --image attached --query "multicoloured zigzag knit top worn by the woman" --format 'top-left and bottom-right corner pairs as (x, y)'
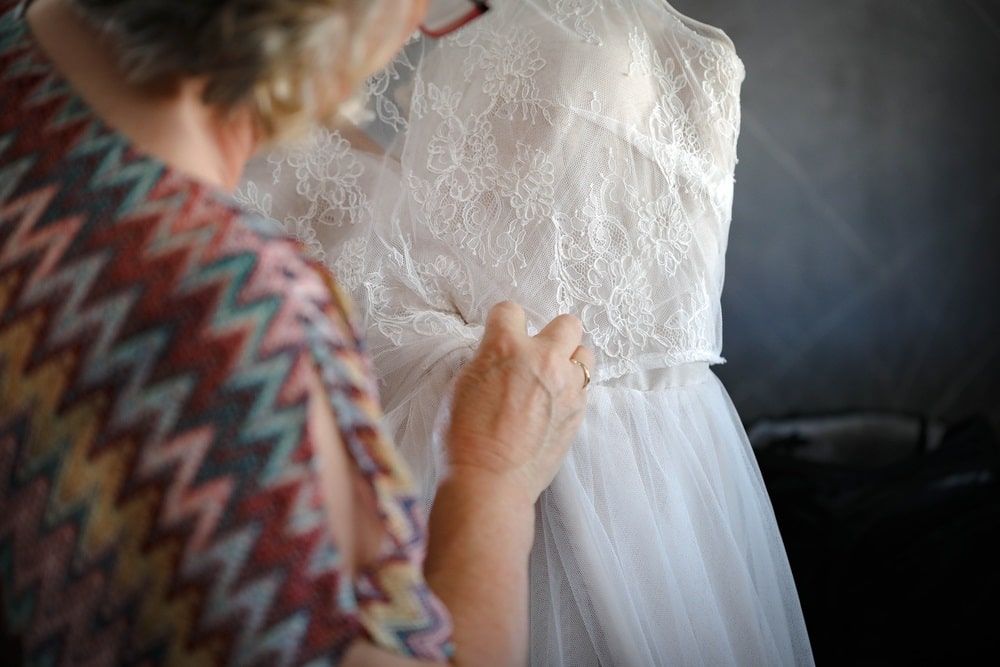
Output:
(0, 0), (451, 666)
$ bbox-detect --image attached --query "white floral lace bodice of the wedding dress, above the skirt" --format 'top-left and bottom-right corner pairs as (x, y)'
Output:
(242, 0), (743, 381)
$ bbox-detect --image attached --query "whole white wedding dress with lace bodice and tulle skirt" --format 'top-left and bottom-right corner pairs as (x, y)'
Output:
(240, 0), (812, 667)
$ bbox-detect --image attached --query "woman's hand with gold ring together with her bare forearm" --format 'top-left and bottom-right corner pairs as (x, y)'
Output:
(416, 302), (594, 667)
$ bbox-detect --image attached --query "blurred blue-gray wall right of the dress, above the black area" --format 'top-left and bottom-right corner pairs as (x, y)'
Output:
(672, 0), (1000, 425)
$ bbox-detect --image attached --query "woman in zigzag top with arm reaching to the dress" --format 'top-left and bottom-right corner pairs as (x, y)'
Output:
(0, 0), (594, 665)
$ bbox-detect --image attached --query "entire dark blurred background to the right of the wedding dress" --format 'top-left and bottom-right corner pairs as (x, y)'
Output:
(671, 0), (1000, 665)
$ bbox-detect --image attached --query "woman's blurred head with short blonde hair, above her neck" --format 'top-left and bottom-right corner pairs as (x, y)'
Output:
(74, 0), (412, 141)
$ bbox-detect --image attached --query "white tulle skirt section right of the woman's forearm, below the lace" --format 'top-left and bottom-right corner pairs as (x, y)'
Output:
(530, 364), (812, 667)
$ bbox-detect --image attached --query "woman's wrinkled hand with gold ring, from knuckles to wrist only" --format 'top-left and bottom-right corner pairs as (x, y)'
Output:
(447, 301), (594, 503)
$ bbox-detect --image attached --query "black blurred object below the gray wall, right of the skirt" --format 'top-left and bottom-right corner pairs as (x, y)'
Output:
(750, 415), (1000, 667)
